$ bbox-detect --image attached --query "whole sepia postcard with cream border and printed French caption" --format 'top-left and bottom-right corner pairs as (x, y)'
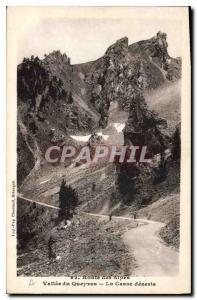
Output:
(7, 7), (191, 294)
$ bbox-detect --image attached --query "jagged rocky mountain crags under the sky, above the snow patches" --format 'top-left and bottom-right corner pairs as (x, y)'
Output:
(17, 32), (181, 186)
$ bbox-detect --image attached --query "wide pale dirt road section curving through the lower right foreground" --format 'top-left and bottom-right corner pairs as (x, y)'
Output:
(123, 219), (179, 276)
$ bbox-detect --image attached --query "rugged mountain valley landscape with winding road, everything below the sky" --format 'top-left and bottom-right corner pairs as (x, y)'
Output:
(17, 32), (181, 276)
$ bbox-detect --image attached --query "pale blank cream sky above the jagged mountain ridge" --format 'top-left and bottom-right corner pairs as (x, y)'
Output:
(17, 17), (182, 64)
